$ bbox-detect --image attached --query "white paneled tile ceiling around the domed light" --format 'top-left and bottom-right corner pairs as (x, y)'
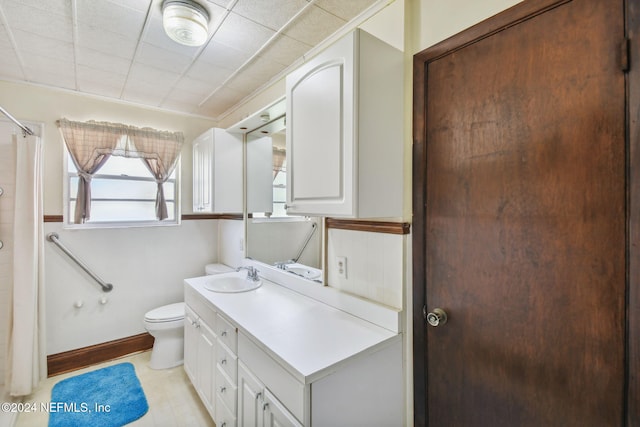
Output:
(0, 0), (379, 119)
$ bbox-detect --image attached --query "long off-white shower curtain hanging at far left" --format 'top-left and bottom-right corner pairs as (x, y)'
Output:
(5, 135), (47, 396)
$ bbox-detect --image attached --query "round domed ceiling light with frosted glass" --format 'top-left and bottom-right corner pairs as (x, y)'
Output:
(162, 0), (209, 46)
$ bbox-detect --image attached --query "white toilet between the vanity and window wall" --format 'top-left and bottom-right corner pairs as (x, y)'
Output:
(144, 264), (234, 369)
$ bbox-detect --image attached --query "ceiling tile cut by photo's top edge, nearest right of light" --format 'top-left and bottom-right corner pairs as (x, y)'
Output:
(233, 0), (308, 31)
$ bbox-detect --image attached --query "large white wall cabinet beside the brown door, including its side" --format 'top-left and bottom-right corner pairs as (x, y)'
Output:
(286, 29), (404, 218)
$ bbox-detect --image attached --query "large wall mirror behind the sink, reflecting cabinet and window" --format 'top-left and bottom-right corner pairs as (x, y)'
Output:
(246, 117), (324, 282)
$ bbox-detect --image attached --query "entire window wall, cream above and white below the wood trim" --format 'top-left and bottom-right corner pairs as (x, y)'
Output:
(0, 81), (242, 354)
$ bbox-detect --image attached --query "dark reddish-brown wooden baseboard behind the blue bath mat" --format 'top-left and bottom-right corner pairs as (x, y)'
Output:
(47, 332), (154, 377)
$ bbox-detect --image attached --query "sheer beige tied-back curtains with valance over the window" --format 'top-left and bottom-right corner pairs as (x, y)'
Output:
(56, 119), (184, 224)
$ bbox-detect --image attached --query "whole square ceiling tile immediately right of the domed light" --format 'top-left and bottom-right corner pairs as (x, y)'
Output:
(212, 13), (275, 53)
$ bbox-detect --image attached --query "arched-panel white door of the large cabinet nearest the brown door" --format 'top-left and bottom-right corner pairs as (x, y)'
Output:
(287, 32), (355, 216)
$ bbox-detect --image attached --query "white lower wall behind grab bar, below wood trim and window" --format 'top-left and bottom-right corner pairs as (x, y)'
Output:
(45, 220), (219, 354)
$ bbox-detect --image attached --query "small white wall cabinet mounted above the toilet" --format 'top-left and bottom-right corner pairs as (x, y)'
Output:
(192, 128), (243, 213)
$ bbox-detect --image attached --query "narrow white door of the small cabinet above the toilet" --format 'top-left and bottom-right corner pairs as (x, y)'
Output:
(192, 130), (213, 212)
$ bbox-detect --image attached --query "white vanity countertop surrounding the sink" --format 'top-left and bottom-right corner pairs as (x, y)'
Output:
(185, 276), (400, 384)
